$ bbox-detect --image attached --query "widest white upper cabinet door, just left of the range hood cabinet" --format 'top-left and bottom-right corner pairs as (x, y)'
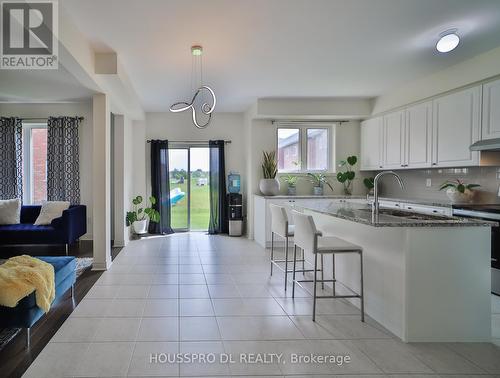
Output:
(432, 86), (481, 167)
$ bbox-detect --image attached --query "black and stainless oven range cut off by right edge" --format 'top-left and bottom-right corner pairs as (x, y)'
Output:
(453, 204), (500, 295)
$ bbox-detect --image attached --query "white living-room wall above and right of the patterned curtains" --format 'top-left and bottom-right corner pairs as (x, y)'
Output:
(0, 101), (93, 239)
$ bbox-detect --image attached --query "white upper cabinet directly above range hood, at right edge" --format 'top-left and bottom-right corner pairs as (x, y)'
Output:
(482, 80), (500, 139)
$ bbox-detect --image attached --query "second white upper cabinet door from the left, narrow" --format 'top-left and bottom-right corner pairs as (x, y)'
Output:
(382, 110), (405, 169)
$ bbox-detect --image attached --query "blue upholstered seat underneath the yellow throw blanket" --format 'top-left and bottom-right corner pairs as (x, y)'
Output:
(0, 256), (76, 347)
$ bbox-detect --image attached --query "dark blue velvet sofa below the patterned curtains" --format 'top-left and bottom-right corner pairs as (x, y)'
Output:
(0, 205), (87, 255)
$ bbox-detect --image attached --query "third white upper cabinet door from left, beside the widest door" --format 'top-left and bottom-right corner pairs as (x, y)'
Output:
(403, 101), (432, 168)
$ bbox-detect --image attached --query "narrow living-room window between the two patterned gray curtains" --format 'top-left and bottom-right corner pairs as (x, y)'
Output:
(23, 123), (47, 205)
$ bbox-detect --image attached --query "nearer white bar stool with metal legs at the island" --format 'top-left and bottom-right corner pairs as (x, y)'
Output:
(292, 210), (365, 322)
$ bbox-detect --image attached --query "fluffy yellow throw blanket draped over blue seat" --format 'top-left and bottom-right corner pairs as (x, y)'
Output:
(0, 255), (56, 313)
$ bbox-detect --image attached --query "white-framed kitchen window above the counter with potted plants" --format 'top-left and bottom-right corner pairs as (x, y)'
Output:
(276, 122), (335, 172)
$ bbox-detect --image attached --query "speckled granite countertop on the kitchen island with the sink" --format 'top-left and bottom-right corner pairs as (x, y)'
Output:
(293, 201), (498, 227)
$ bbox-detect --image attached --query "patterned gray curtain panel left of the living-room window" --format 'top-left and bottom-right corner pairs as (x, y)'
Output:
(0, 117), (23, 200)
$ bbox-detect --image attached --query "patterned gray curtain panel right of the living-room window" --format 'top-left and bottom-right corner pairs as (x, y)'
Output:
(47, 117), (81, 205)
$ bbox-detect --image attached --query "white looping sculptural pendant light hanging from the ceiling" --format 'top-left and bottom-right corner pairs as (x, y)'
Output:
(170, 46), (217, 129)
